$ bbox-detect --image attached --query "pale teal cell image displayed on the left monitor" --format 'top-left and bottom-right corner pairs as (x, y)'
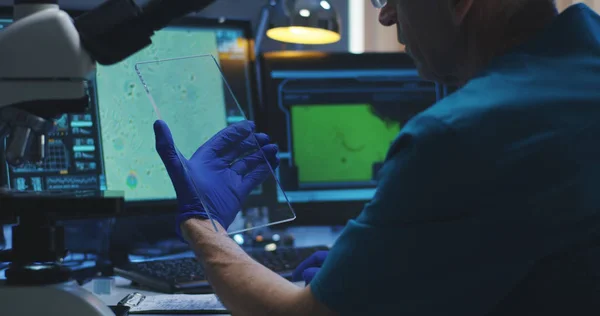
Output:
(96, 28), (226, 201)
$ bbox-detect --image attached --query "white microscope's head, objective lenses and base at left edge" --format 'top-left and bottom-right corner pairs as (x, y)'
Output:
(0, 9), (114, 316)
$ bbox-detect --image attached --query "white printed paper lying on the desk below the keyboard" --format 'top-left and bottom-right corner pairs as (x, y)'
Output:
(129, 294), (227, 314)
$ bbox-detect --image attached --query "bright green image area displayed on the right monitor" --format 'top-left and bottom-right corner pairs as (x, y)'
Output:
(291, 104), (400, 185)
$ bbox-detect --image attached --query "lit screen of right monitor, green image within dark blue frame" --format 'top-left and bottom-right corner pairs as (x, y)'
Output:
(272, 69), (439, 203)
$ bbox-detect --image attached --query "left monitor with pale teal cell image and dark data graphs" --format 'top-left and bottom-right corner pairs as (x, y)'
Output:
(3, 12), (276, 211)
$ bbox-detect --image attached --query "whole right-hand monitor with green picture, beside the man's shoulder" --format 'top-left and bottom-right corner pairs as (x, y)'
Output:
(263, 52), (446, 221)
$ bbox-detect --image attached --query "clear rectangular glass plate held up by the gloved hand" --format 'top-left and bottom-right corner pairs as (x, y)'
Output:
(135, 55), (295, 234)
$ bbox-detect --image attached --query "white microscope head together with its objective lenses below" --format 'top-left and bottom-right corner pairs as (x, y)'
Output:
(0, 4), (96, 166)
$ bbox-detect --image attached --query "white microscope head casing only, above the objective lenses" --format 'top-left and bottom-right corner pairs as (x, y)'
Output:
(0, 5), (96, 114)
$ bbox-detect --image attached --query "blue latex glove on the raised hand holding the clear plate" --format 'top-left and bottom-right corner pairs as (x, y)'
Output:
(154, 120), (279, 240)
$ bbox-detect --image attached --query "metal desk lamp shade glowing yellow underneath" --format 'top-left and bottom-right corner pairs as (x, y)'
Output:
(267, 0), (341, 44)
